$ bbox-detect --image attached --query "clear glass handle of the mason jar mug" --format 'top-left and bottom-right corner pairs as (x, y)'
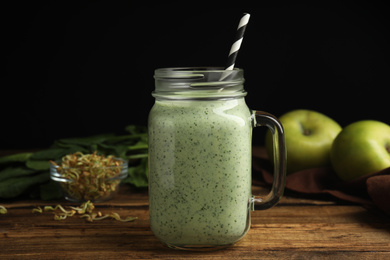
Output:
(252, 111), (287, 210)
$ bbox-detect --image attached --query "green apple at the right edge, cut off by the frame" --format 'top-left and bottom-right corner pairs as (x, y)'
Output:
(330, 120), (390, 181)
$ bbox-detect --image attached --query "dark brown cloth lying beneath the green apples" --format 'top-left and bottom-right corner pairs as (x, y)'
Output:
(253, 148), (390, 215)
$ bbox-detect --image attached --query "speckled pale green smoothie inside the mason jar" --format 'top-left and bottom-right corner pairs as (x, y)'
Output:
(149, 97), (252, 247)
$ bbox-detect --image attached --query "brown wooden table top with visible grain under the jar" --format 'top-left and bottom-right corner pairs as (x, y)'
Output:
(0, 186), (390, 259)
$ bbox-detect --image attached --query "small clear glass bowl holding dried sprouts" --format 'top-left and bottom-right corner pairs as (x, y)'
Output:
(50, 158), (128, 202)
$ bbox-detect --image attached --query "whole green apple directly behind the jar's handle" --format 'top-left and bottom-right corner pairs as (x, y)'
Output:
(265, 109), (342, 173)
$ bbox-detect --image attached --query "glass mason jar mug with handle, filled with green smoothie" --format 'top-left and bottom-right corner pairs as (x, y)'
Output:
(148, 67), (286, 250)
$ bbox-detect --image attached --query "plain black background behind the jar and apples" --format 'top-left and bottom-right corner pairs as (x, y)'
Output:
(0, 1), (390, 149)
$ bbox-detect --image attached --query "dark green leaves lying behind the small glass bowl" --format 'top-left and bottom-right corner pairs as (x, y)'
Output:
(0, 125), (148, 200)
